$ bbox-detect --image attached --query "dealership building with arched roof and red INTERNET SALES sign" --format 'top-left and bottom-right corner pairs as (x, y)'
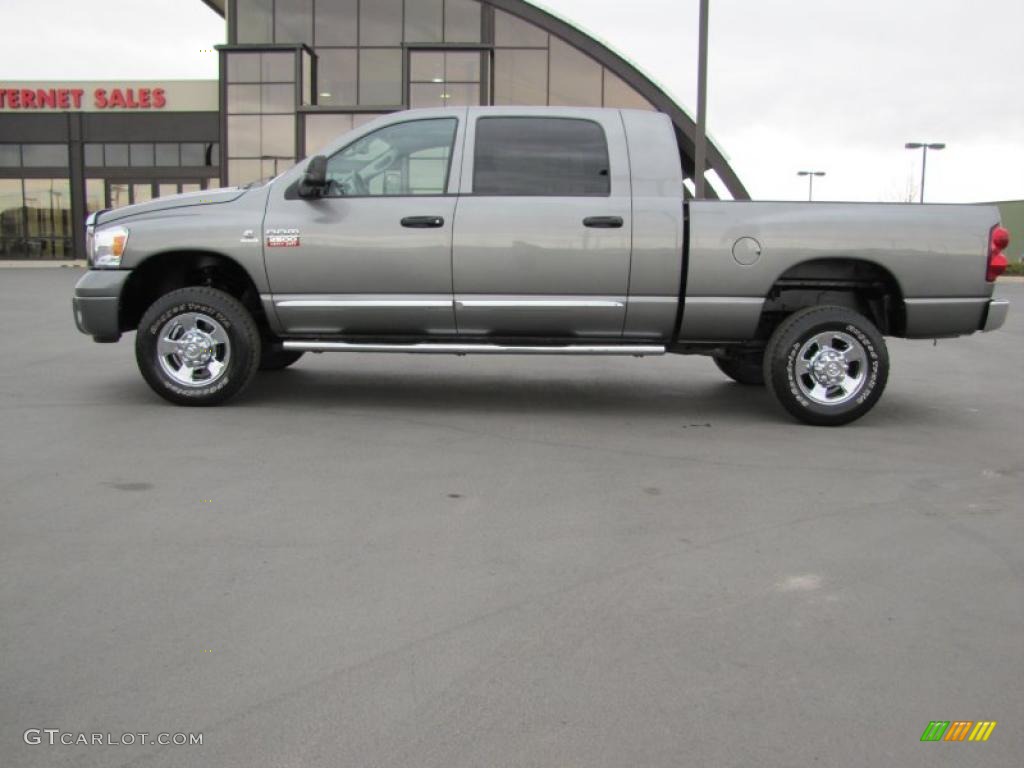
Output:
(0, 0), (749, 259)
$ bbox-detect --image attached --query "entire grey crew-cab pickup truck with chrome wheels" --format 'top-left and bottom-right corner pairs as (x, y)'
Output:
(74, 108), (1008, 425)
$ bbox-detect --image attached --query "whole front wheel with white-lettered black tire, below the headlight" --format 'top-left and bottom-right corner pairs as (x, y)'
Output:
(135, 288), (260, 406)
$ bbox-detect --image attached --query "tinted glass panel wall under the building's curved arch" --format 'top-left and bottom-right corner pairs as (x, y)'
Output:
(225, 0), (652, 183)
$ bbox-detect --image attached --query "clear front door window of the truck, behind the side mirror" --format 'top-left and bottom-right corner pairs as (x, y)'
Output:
(327, 118), (458, 198)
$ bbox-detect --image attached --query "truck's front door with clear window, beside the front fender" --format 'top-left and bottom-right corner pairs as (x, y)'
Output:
(264, 110), (465, 337)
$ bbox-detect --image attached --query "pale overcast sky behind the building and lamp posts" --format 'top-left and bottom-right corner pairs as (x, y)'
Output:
(0, 0), (1024, 202)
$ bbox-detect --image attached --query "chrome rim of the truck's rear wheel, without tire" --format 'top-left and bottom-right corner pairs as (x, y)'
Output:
(793, 331), (868, 406)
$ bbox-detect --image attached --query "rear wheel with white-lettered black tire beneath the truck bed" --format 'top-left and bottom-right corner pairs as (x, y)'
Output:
(764, 306), (889, 427)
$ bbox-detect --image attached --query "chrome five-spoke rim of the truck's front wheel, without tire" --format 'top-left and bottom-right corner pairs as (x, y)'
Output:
(157, 312), (231, 387)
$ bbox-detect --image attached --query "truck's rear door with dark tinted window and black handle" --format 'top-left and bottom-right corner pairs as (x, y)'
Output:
(453, 110), (633, 338)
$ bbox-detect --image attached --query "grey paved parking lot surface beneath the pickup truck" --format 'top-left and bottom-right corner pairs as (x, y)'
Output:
(0, 269), (1024, 768)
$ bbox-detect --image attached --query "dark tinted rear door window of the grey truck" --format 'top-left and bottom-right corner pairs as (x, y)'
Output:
(473, 118), (611, 198)
